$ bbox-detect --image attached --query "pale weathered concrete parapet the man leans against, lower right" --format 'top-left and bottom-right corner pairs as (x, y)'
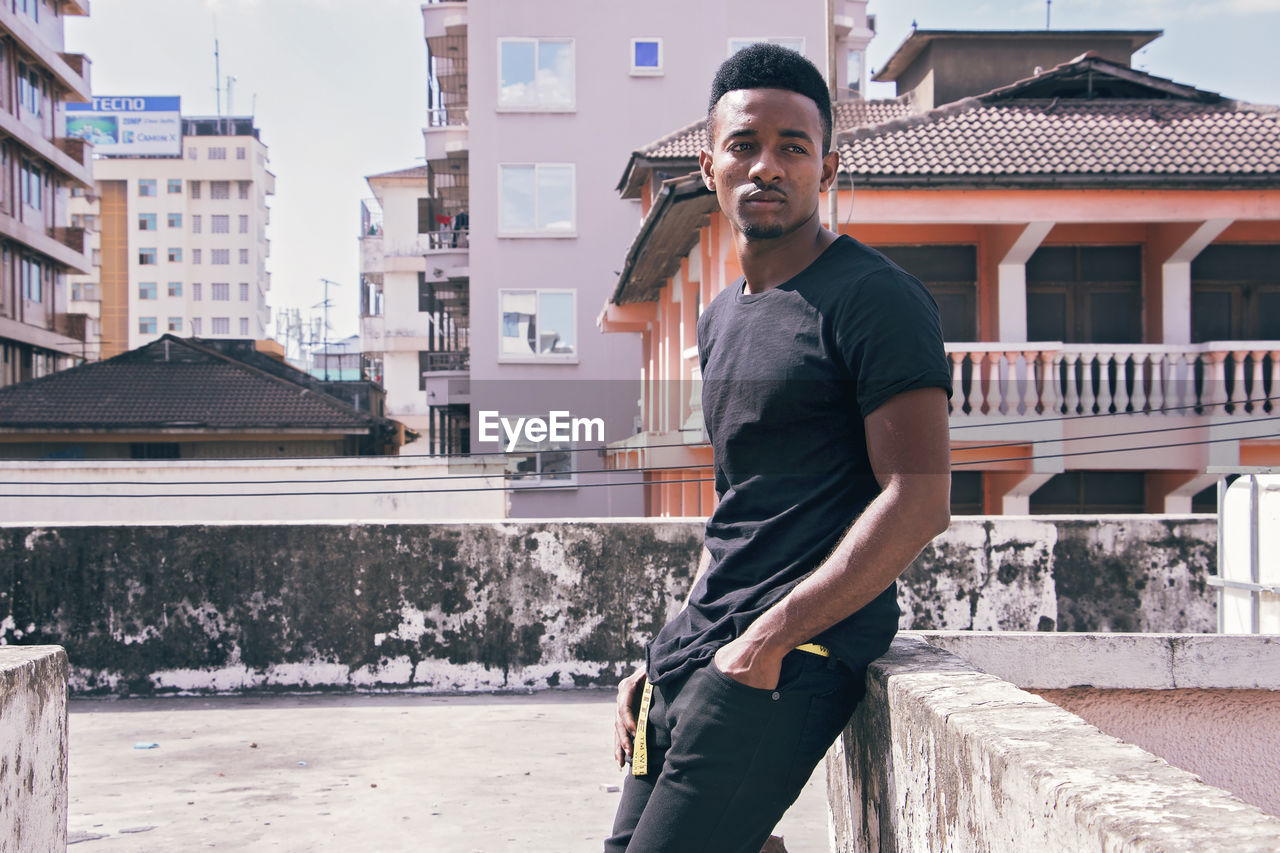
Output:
(827, 637), (1280, 853)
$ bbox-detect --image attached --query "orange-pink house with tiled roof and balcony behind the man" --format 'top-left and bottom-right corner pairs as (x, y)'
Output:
(602, 31), (1280, 515)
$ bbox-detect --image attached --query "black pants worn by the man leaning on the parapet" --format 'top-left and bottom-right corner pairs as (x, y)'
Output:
(604, 652), (865, 853)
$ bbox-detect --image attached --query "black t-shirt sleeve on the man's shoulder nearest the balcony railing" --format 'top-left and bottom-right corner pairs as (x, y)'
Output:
(836, 266), (951, 418)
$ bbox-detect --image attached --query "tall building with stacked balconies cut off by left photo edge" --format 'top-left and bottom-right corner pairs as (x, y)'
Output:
(0, 0), (92, 387)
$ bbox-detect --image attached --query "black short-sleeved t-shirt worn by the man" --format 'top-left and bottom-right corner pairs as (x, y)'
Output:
(648, 236), (951, 683)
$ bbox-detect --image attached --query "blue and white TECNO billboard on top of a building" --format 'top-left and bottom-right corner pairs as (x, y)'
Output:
(65, 96), (182, 158)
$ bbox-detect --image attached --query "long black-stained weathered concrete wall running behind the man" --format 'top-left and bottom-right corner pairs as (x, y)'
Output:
(0, 517), (1215, 694)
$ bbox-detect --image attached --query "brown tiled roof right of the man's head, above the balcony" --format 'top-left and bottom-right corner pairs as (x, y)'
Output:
(840, 59), (1280, 182)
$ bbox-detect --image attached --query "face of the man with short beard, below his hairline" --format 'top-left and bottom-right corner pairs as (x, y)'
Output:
(698, 88), (838, 241)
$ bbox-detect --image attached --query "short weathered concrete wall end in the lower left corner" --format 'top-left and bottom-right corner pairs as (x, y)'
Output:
(0, 646), (68, 853)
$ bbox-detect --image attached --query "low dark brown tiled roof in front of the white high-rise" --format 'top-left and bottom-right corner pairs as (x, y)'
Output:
(0, 334), (384, 433)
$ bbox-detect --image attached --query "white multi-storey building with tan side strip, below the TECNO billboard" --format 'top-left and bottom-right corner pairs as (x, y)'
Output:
(70, 117), (275, 359)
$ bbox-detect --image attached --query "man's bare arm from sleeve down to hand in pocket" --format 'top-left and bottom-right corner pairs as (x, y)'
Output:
(716, 388), (951, 689)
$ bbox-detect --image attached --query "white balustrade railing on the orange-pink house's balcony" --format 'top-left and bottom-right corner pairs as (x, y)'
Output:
(947, 341), (1280, 418)
